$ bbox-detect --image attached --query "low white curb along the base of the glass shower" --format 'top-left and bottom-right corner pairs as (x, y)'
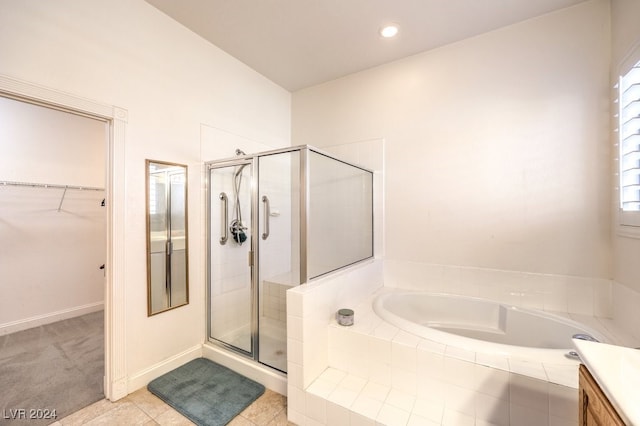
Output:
(202, 343), (287, 396)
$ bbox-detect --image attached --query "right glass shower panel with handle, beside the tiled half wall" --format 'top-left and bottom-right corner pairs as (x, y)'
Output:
(258, 151), (300, 372)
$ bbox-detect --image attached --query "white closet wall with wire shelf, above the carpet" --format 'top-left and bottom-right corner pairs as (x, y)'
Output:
(0, 97), (108, 335)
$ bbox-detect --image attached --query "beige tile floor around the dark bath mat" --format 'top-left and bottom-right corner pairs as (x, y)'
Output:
(51, 388), (293, 426)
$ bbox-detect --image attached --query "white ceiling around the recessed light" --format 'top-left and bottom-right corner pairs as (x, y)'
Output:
(146, 0), (585, 92)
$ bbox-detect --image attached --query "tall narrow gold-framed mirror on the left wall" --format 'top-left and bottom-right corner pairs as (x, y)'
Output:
(146, 160), (189, 316)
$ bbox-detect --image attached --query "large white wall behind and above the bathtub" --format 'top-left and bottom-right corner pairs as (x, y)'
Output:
(292, 0), (611, 278)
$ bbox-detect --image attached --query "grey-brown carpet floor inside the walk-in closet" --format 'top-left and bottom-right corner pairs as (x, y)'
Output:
(0, 311), (104, 426)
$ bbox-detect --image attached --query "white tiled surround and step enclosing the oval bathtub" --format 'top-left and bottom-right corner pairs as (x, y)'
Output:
(287, 261), (636, 426)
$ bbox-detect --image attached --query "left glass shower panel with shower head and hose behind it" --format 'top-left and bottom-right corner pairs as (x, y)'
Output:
(209, 161), (255, 356)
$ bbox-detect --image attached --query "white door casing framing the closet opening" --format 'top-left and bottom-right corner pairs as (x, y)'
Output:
(0, 75), (128, 401)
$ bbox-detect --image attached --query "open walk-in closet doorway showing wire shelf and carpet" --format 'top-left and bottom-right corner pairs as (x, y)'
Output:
(0, 96), (110, 424)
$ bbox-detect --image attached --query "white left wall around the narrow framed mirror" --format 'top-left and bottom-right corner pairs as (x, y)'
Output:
(0, 0), (290, 390)
